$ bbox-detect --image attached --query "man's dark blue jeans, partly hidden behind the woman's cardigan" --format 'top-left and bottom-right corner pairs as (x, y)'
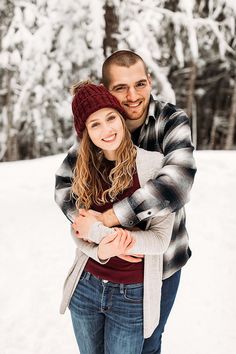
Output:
(142, 270), (181, 354)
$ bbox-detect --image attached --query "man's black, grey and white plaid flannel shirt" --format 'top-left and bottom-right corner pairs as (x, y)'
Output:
(55, 96), (196, 279)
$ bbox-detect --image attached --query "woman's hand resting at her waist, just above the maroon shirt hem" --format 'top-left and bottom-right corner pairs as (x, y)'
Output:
(98, 228), (135, 260)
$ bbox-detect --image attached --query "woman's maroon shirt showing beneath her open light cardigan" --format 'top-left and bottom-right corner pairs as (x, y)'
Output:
(84, 160), (144, 284)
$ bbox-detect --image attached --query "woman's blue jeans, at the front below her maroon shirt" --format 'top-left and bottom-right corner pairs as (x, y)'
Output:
(69, 272), (144, 354)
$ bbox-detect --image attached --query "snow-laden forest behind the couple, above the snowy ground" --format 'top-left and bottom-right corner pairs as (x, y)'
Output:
(0, 0), (236, 161)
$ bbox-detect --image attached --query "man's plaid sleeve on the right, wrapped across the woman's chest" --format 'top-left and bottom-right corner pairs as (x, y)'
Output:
(113, 104), (196, 227)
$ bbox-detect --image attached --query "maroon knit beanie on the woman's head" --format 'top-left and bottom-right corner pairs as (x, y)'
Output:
(72, 83), (127, 137)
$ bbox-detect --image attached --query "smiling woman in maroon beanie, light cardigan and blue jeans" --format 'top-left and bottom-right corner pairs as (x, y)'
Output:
(61, 82), (174, 354)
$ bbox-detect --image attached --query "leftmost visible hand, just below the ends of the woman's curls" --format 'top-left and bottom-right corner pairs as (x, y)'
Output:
(72, 209), (98, 240)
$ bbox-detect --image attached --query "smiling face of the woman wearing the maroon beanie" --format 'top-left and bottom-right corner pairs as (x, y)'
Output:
(86, 108), (124, 160)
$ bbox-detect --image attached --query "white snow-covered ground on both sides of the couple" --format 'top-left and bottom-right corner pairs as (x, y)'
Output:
(0, 151), (236, 354)
